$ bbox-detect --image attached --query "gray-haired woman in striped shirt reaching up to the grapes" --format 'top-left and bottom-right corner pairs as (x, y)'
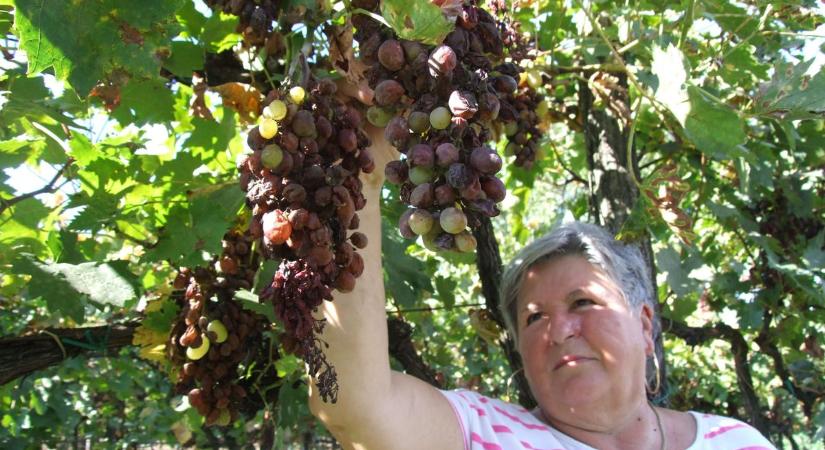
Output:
(310, 135), (774, 450)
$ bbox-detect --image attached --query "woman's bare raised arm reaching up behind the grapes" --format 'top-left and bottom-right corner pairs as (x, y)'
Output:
(310, 120), (463, 450)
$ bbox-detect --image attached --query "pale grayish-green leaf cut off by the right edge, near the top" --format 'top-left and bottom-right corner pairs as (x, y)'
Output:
(753, 59), (825, 121)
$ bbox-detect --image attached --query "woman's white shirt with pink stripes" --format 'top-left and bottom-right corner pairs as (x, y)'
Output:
(441, 389), (776, 450)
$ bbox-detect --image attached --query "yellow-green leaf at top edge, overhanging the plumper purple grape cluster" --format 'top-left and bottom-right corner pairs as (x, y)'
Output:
(381, 0), (454, 45)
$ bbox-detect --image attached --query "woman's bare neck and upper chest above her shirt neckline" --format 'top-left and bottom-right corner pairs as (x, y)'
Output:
(538, 399), (665, 450)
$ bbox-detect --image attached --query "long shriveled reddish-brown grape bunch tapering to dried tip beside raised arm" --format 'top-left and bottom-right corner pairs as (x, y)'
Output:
(238, 79), (375, 402)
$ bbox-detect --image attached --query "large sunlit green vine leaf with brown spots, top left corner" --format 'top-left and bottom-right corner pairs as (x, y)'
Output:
(15, 0), (181, 96)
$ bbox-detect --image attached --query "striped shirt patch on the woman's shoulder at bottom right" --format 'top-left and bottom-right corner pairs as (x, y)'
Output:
(688, 411), (776, 450)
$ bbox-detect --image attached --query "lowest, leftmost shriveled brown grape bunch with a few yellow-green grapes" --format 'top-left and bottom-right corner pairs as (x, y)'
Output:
(166, 231), (266, 426)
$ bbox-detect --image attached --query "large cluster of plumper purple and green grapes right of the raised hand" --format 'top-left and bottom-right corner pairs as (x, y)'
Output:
(353, 0), (538, 252)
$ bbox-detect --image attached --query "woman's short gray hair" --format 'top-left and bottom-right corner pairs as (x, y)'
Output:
(499, 222), (658, 343)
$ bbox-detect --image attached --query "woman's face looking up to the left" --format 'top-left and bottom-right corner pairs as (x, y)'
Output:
(516, 255), (653, 426)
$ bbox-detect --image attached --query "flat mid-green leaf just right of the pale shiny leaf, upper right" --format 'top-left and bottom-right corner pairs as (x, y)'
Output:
(685, 86), (747, 161)
